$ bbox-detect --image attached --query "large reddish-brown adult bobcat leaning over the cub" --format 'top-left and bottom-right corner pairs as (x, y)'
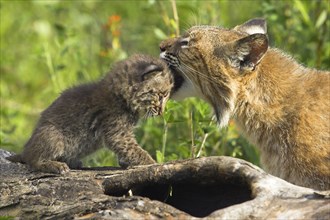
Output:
(160, 19), (330, 189)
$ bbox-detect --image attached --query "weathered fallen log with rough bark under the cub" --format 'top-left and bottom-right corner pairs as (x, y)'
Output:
(0, 150), (330, 219)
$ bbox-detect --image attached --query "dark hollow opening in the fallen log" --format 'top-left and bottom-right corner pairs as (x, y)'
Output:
(107, 179), (253, 217)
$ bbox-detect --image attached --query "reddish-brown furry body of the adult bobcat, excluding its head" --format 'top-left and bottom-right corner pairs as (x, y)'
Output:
(235, 49), (330, 189)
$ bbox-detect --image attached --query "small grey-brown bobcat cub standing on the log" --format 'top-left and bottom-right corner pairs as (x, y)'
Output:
(9, 55), (173, 173)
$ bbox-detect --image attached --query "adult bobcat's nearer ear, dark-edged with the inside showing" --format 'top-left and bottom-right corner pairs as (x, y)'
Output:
(227, 34), (268, 71)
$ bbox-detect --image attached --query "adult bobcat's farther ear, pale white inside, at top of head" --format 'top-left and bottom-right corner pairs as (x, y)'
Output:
(234, 18), (267, 35)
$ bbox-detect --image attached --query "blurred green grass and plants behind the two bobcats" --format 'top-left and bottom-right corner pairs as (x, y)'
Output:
(0, 0), (330, 166)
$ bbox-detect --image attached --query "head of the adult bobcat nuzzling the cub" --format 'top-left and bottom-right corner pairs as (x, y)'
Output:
(160, 19), (268, 126)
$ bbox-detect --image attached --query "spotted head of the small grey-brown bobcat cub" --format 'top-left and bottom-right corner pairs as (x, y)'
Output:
(109, 54), (174, 117)
